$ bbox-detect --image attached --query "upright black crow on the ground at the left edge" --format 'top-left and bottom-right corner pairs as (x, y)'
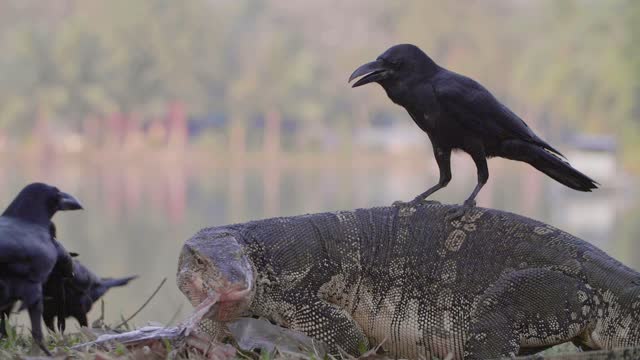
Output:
(0, 183), (82, 353)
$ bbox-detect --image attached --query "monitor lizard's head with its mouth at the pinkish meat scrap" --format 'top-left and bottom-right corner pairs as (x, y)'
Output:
(177, 230), (255, 321)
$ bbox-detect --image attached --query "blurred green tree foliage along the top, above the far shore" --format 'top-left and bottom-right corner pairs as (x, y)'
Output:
(0, 0), (640, 159)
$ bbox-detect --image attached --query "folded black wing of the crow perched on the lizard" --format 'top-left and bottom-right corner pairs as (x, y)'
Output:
(431, 70), (562, 156)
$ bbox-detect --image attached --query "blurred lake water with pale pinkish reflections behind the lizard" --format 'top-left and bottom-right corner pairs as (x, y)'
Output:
(0, 156), (640, 326)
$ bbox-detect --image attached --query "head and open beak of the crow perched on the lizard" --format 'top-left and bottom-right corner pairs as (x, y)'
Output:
(349, 44), (438, 87)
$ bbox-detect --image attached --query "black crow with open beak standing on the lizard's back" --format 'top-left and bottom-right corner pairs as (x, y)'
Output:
(349, 44), (597, 208)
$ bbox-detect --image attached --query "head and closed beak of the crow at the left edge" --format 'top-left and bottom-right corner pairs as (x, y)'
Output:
(2, 183), (82, 227)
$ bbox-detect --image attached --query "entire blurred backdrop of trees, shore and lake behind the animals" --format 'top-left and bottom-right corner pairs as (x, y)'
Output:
(0, 0), (640, 325)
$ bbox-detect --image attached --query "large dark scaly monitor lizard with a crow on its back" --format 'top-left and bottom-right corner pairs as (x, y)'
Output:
(178, 202), (640, 359)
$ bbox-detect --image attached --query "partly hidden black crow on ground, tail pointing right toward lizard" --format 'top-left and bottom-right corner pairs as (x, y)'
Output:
(43, 253), (137, 333)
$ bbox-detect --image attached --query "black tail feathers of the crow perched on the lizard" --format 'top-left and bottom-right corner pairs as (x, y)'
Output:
(503, 140), (600, 192)
